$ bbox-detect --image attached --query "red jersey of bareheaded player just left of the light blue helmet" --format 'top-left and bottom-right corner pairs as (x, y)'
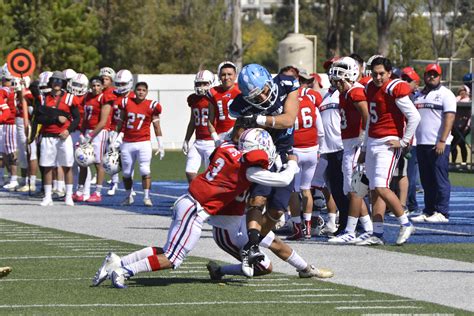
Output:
(209, 84), (240, 134)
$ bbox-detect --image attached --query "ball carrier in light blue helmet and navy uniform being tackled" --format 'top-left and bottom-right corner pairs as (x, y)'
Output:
(229, 64), (299, 271)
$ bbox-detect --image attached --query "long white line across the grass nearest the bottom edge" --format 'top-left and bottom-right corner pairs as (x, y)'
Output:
(0, 300), (413, 308)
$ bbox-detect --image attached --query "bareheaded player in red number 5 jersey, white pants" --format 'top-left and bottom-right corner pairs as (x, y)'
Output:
(358, 57), (420, 245)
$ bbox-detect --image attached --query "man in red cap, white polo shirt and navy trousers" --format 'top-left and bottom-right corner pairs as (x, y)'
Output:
(412, 64), (456, 223)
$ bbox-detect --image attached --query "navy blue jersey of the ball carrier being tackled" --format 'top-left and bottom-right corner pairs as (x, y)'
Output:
(229, 75), (300, 152)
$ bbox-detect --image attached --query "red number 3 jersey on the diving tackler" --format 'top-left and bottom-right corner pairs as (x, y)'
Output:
(189, 142), (268, 215)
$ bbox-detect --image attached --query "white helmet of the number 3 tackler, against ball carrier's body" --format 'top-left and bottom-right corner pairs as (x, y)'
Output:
(239, 128), (277, 168)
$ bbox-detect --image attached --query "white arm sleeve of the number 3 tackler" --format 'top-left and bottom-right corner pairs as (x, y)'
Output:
(246, 160), (298, 187)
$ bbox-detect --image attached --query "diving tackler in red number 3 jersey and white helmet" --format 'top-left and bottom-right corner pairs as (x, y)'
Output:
(93, 129), (297, 288)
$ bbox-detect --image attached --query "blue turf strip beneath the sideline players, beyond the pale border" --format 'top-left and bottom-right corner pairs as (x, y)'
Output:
(21, 181), (474, 244)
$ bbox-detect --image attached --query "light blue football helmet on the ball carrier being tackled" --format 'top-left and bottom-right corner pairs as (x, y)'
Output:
(238, 64), (278, 110)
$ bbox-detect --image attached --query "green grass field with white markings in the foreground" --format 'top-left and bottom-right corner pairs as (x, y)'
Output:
(0, 220), (467, 315)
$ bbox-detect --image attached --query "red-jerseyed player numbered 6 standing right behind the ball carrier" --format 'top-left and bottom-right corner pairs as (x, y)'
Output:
(287, 92), (324, 240)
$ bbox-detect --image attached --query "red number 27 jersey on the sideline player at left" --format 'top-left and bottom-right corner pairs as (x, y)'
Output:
(120, 97), (161, 142)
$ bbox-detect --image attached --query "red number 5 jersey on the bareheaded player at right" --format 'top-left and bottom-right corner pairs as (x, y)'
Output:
(366, 79), (411, 138)
